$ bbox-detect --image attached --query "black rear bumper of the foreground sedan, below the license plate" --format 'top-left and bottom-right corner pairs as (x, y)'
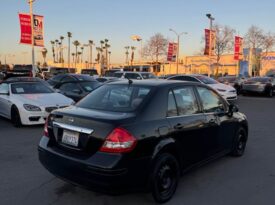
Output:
(38, 137), (149, 194)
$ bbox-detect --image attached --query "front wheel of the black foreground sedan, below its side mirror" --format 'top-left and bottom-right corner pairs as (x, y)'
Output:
(231, 127), (247, 157)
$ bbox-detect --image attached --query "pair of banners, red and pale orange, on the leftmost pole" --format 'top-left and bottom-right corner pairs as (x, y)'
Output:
(19, 13), (44, 47)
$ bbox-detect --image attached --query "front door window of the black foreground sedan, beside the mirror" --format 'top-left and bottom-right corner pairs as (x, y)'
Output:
(197, 87), (225, 113)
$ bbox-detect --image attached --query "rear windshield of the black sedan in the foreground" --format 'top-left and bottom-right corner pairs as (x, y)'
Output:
(76, 84), (151, 112)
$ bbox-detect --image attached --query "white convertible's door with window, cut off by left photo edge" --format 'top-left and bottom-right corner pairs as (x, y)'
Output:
(0, 83), (12, 118)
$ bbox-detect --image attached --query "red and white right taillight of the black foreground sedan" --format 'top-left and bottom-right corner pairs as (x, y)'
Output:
(100, 128), (137, 153)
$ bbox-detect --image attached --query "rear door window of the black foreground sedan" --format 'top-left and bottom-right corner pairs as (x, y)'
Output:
(173, 87), (200, 115)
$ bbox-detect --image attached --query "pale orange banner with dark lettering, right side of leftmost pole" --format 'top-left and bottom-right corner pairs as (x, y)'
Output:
(33, 15), (44, 47)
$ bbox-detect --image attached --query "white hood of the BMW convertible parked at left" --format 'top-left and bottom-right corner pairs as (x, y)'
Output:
(14, 93), (74, 106)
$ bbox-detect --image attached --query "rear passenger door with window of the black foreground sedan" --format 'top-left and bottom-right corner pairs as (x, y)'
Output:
(167, 86), (206, 167)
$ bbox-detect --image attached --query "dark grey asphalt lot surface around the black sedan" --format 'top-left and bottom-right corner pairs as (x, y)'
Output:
(0, 96), (275, 205)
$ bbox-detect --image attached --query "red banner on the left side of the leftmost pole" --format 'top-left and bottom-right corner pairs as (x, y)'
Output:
(19, 14), (32, 44)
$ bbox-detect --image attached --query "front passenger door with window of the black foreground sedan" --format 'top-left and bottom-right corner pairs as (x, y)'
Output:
(197, 86), (235, 157)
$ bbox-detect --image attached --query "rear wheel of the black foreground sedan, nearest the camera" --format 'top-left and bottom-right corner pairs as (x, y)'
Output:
(150, 153), (180, 203)
